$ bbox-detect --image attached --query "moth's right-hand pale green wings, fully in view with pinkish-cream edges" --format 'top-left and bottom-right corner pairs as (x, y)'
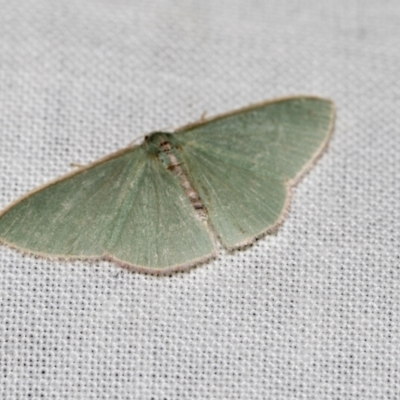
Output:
(176, 97), (334, 249)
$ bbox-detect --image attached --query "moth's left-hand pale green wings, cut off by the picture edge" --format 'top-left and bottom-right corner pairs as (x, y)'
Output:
(0, 147), (215, 272)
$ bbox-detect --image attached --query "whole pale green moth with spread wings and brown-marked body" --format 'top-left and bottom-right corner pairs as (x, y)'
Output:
(0, 96), (335, 273)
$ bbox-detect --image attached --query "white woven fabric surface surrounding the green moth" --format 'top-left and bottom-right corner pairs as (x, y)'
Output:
(0, 0), (400, 400)
